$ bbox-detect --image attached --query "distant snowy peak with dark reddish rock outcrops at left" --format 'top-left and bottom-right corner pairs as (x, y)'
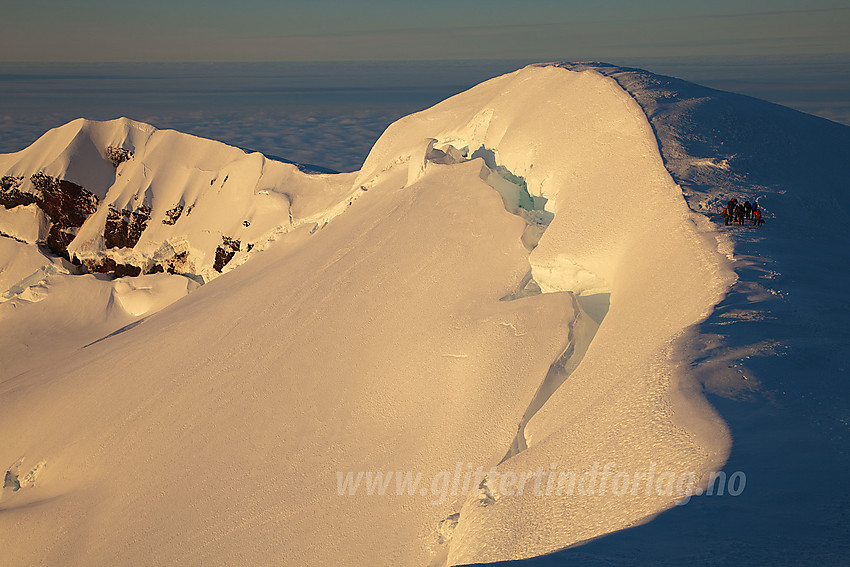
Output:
(0, 115), (358, 298)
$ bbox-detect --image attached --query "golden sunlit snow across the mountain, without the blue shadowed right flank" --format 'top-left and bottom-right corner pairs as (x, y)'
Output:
(0, 65), (840, 566)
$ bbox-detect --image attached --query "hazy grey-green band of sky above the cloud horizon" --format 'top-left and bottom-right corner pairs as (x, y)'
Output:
(0, 0), (850, 62)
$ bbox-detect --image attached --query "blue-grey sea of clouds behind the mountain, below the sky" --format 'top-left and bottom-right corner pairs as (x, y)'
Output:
(0, 59), (850, 171)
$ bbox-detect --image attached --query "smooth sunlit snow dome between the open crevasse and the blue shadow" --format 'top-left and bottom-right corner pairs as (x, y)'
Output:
(361, 64), (731, 563)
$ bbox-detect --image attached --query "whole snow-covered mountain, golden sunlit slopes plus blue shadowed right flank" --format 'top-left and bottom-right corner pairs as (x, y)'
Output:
(0, 64), (850, 565)
